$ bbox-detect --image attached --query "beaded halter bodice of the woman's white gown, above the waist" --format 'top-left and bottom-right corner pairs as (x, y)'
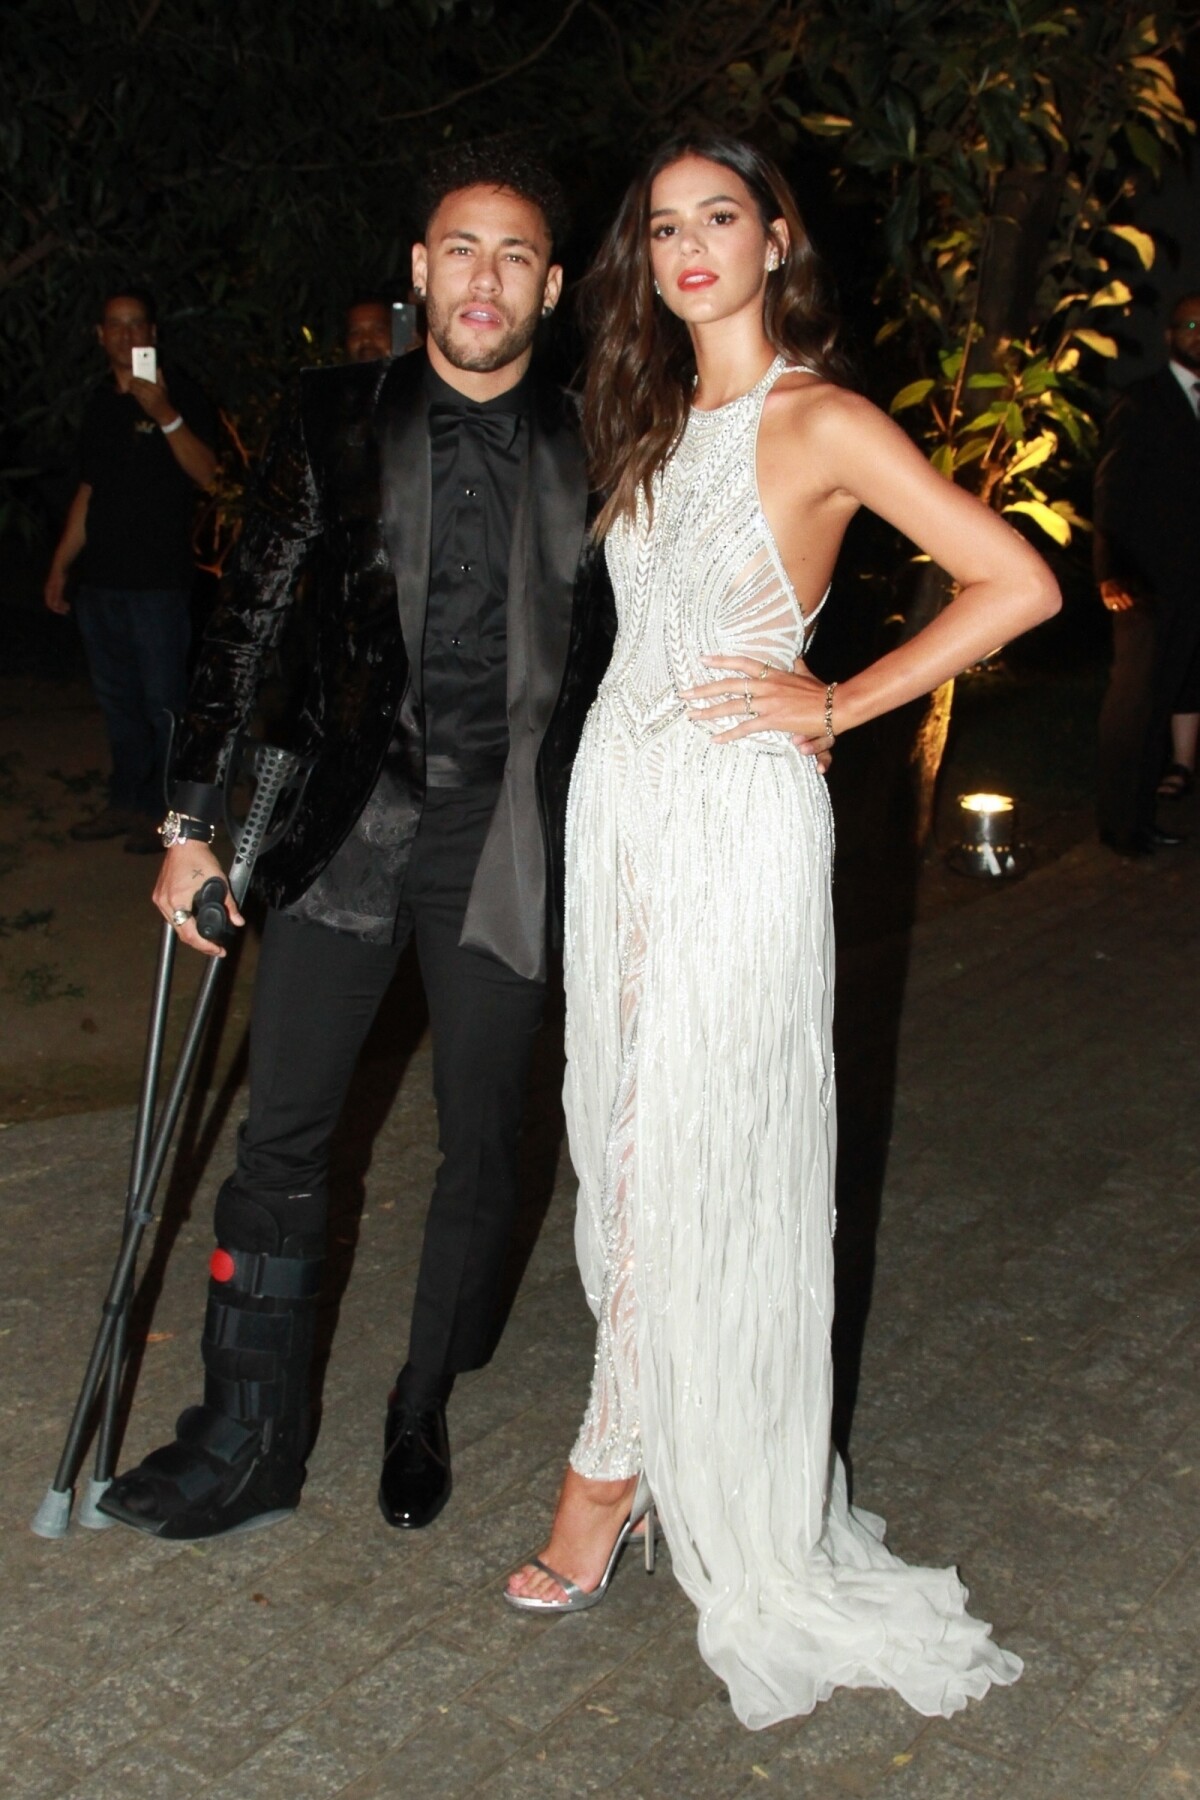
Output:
(601, 356), (824, 749)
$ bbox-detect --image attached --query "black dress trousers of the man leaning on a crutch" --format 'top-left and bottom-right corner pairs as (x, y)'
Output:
(234, 788), (545, 1393)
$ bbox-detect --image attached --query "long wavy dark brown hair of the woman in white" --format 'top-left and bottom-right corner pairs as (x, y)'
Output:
(579, 131), (849, 536)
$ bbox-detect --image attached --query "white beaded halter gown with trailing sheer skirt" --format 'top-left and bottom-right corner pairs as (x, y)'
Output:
(565, 358), (1022, 1728)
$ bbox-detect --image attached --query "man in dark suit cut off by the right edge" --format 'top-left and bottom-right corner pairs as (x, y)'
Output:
(1096, 293), (1200, 855)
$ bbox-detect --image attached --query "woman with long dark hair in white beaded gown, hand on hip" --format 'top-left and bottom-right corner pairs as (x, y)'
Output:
(506, 137), (1058, 1726)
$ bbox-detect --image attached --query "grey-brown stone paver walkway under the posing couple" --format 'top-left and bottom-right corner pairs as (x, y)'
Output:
(0, 831), (1200, 1800)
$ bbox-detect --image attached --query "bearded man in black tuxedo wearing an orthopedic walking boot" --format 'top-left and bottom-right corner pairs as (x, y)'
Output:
(103, 148), (612, 1541)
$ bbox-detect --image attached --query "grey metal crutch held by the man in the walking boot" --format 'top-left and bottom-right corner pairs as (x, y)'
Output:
(31, 736), (308, 1537)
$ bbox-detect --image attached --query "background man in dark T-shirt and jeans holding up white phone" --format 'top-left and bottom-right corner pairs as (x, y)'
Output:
(45, 286), (216, 851)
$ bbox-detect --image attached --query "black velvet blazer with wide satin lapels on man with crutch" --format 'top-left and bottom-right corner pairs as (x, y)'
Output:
(171, 353), (615, 977)
